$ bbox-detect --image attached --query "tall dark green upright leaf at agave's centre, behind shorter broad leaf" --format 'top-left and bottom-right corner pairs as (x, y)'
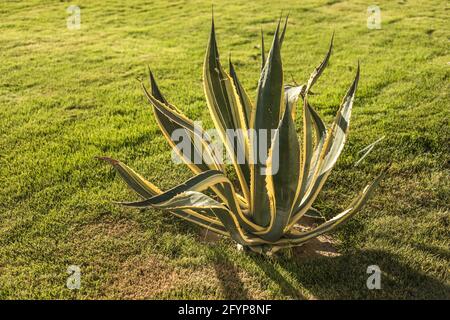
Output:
(250, 20), (283, 226)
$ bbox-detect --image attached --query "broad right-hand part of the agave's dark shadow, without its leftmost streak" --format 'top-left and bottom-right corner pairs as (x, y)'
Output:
(246, 250), (450, 299)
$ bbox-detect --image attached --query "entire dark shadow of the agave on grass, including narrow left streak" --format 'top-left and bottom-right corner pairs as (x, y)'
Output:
(201, 225), (450, 300)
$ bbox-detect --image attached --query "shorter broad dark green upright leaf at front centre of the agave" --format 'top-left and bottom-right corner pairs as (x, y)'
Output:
(260, 106), (300, 241)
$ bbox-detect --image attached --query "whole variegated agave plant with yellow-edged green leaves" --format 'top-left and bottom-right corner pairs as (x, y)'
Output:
(100, 18), (386, 254)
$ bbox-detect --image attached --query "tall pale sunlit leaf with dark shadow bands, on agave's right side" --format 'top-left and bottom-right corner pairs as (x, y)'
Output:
(288, 64), (360, 228)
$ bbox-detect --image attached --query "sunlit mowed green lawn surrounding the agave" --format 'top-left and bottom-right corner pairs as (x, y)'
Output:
(0, 0), (450, 299)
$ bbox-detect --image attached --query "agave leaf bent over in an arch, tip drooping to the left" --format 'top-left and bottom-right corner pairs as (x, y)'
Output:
(121, 170), (263, 232)
